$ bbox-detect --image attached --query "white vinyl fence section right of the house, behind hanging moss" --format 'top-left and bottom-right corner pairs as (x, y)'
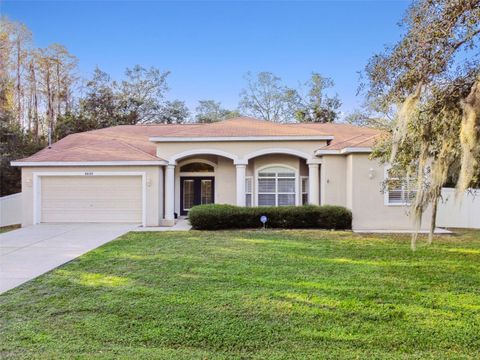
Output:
(437, 188), (480, 229)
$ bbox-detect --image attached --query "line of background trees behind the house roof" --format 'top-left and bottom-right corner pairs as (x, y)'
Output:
(0, 17), (341, 196)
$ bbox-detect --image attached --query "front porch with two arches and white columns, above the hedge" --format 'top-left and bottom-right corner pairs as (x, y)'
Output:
(162, 150), (321, 226)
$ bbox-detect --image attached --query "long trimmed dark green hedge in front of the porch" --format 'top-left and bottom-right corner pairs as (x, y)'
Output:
(188, 204), (352, 230)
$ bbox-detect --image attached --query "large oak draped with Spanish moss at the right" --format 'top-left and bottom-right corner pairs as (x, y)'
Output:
(366, 0), (480, 248)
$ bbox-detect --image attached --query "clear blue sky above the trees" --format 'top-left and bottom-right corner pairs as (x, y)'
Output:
(0, 0), (409, 118)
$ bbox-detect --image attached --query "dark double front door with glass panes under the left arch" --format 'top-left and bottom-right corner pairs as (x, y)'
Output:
(180, 176), (215, 215)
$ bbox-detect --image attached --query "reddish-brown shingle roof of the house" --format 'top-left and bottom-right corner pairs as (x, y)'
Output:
(14, 117), (381, 162)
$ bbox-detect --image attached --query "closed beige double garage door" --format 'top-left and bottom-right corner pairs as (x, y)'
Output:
(41, 176), (142, 223)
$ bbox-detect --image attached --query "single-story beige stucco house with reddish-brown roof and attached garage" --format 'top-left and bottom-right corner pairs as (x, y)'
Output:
(12, 117), (426, 230)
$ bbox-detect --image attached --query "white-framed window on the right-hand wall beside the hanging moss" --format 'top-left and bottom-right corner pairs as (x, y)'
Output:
(385, 168), (417, 205)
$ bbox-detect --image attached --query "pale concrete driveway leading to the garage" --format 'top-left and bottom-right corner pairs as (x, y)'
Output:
(0, 224), (139, 293)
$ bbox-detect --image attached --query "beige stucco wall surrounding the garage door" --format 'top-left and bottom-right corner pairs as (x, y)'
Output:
(22, 166), (163, 226)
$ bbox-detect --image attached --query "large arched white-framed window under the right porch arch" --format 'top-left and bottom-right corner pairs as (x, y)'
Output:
(257, 166), (296, 206)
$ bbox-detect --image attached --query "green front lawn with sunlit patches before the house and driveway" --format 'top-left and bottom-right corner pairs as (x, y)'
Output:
(0, 231), (480, 359)
